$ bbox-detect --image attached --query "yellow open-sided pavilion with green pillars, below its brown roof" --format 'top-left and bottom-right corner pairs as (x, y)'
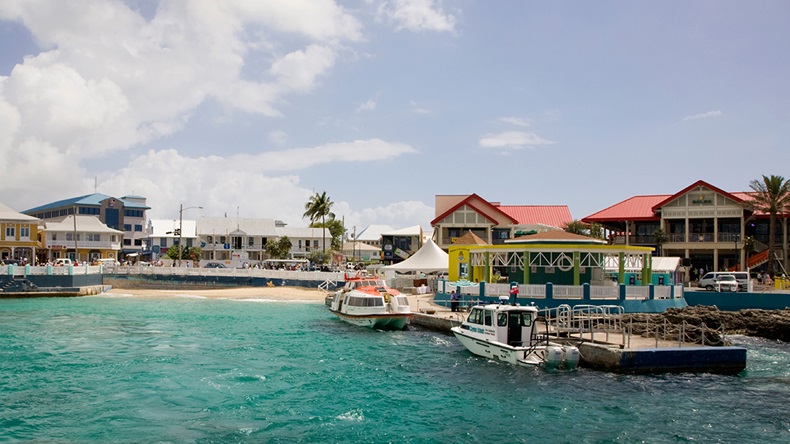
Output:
(448, 243), (669, 286)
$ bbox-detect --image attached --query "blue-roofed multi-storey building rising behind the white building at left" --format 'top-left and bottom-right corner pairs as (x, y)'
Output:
(23, 193), (151, 259)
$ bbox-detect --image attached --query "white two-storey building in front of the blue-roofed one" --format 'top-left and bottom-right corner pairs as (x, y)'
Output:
(43, 215), (124, 263)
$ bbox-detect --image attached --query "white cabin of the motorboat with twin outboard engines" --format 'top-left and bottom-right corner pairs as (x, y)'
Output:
(461, 304), (538, 347)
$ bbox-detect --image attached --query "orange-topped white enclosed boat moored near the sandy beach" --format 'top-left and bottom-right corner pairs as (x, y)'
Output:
(329, 275), (412, 330)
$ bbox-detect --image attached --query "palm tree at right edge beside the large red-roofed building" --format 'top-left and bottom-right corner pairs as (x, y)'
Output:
(747, 175), (790, 274)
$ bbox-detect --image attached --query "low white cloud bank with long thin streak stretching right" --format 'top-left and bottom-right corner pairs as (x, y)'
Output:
(93, 139), (416, 226)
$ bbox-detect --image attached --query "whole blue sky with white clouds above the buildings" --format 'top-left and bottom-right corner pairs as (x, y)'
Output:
(0, 0), (790, 232)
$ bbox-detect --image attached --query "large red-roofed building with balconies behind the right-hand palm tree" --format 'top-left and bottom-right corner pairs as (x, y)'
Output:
(582, 180), (790, 271)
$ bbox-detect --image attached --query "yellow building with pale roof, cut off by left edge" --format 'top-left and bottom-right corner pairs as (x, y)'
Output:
(0, 203), (41, 263)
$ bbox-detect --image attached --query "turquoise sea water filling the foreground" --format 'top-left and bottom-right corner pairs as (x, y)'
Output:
(0, 296), (790, 443)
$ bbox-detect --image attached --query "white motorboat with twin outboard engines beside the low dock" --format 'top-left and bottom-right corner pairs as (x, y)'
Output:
(452, 304), (579, 370)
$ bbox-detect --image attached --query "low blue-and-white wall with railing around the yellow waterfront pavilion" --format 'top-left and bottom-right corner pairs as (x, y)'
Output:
(434, 280), (688, 313)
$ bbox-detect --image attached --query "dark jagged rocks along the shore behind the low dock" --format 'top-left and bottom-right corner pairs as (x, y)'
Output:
(623, 306), (790, 345)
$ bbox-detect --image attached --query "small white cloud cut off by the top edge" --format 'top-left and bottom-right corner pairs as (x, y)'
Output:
(378, 0), (456, 32)
